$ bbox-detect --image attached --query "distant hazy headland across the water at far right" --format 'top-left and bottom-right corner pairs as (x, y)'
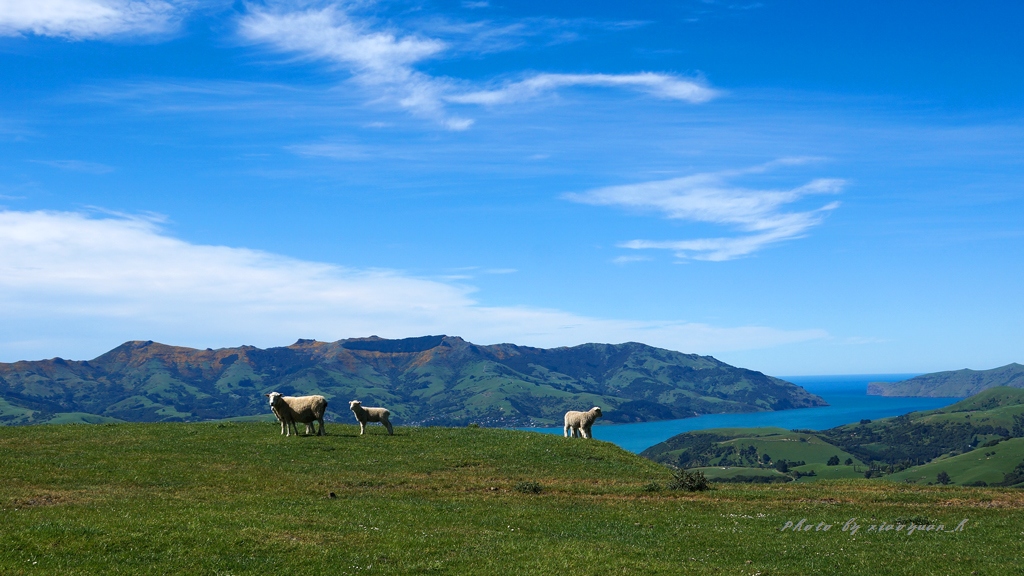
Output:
(867, 363), (1024, 398)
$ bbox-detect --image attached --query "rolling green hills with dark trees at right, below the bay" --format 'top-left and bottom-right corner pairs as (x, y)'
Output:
(641, 387), (1024, 486)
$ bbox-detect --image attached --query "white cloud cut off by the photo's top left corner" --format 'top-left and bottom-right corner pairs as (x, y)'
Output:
(0, 0), (193, 40)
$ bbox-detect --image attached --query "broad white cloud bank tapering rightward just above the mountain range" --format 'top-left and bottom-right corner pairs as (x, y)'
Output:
(0, 211), (826, 361)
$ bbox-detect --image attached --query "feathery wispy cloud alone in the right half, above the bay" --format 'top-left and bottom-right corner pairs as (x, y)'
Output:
(564, 158), (846, 260)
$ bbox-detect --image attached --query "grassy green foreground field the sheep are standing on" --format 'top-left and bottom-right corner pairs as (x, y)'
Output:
(0, 422), (1024, 576)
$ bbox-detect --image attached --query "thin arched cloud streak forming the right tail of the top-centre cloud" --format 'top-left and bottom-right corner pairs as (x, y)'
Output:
(446, 72), (718, 105)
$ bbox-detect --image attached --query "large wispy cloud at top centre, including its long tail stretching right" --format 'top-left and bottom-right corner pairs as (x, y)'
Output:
(239, 5), (719, 130)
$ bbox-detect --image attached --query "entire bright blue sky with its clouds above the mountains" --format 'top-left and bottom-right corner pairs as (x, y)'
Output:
(0, 0), (1024, 375)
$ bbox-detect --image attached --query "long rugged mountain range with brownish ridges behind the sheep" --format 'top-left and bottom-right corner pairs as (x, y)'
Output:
(0, 336), (824, 426)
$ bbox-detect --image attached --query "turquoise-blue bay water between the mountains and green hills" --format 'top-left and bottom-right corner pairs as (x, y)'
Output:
(520, 374), (963, 453)
